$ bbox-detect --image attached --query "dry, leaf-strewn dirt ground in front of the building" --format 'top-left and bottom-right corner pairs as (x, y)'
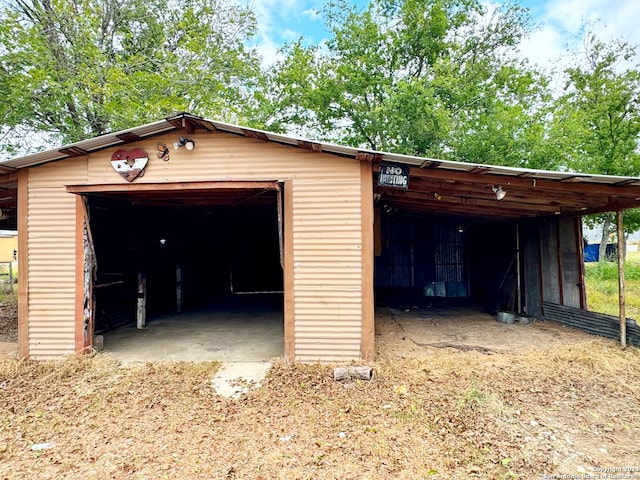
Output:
(0, 306), (640, 479)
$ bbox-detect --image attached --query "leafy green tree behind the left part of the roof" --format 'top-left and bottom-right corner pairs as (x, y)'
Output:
(0, 0), (260, 153)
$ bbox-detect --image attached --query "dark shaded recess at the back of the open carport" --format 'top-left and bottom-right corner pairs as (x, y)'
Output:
(375, 210), (535, 315)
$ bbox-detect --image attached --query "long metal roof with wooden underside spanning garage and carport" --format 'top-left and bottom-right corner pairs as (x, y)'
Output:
(0, 113), (640, 218)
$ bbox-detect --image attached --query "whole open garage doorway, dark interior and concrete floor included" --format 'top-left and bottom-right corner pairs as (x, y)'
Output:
(75, 182), (284, 362)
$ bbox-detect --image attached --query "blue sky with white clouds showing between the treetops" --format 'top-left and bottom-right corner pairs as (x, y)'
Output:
(247, 0), (640, 66)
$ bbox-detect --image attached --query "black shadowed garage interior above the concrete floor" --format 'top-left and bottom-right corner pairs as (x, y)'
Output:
(85, 189), (283, 342)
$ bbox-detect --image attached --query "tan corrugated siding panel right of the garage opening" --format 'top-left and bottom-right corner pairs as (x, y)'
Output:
(293, 178), (362, 361)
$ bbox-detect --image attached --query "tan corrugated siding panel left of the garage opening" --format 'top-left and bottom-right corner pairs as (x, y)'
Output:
(28, 160), (86, 359)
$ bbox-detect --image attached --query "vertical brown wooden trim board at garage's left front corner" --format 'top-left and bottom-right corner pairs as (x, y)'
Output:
(18, 168), (29, 359)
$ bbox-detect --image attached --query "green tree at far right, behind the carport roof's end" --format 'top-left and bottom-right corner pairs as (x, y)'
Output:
(551, 31), (640, 260)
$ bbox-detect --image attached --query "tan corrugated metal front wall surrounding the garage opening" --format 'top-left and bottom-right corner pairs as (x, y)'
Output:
(29, 133), (362, 361)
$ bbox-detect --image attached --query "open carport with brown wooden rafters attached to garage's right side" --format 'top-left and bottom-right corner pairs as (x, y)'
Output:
(371, 158), (640, 343)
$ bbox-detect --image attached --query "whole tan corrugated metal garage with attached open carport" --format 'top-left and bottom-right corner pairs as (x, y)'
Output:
(0, 113), (640, 361)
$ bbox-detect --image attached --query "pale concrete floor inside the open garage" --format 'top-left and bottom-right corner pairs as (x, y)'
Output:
(103, 296), (284, 363)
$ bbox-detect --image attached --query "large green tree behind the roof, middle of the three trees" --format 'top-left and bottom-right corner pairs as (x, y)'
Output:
(258, 0), (547, 166)
